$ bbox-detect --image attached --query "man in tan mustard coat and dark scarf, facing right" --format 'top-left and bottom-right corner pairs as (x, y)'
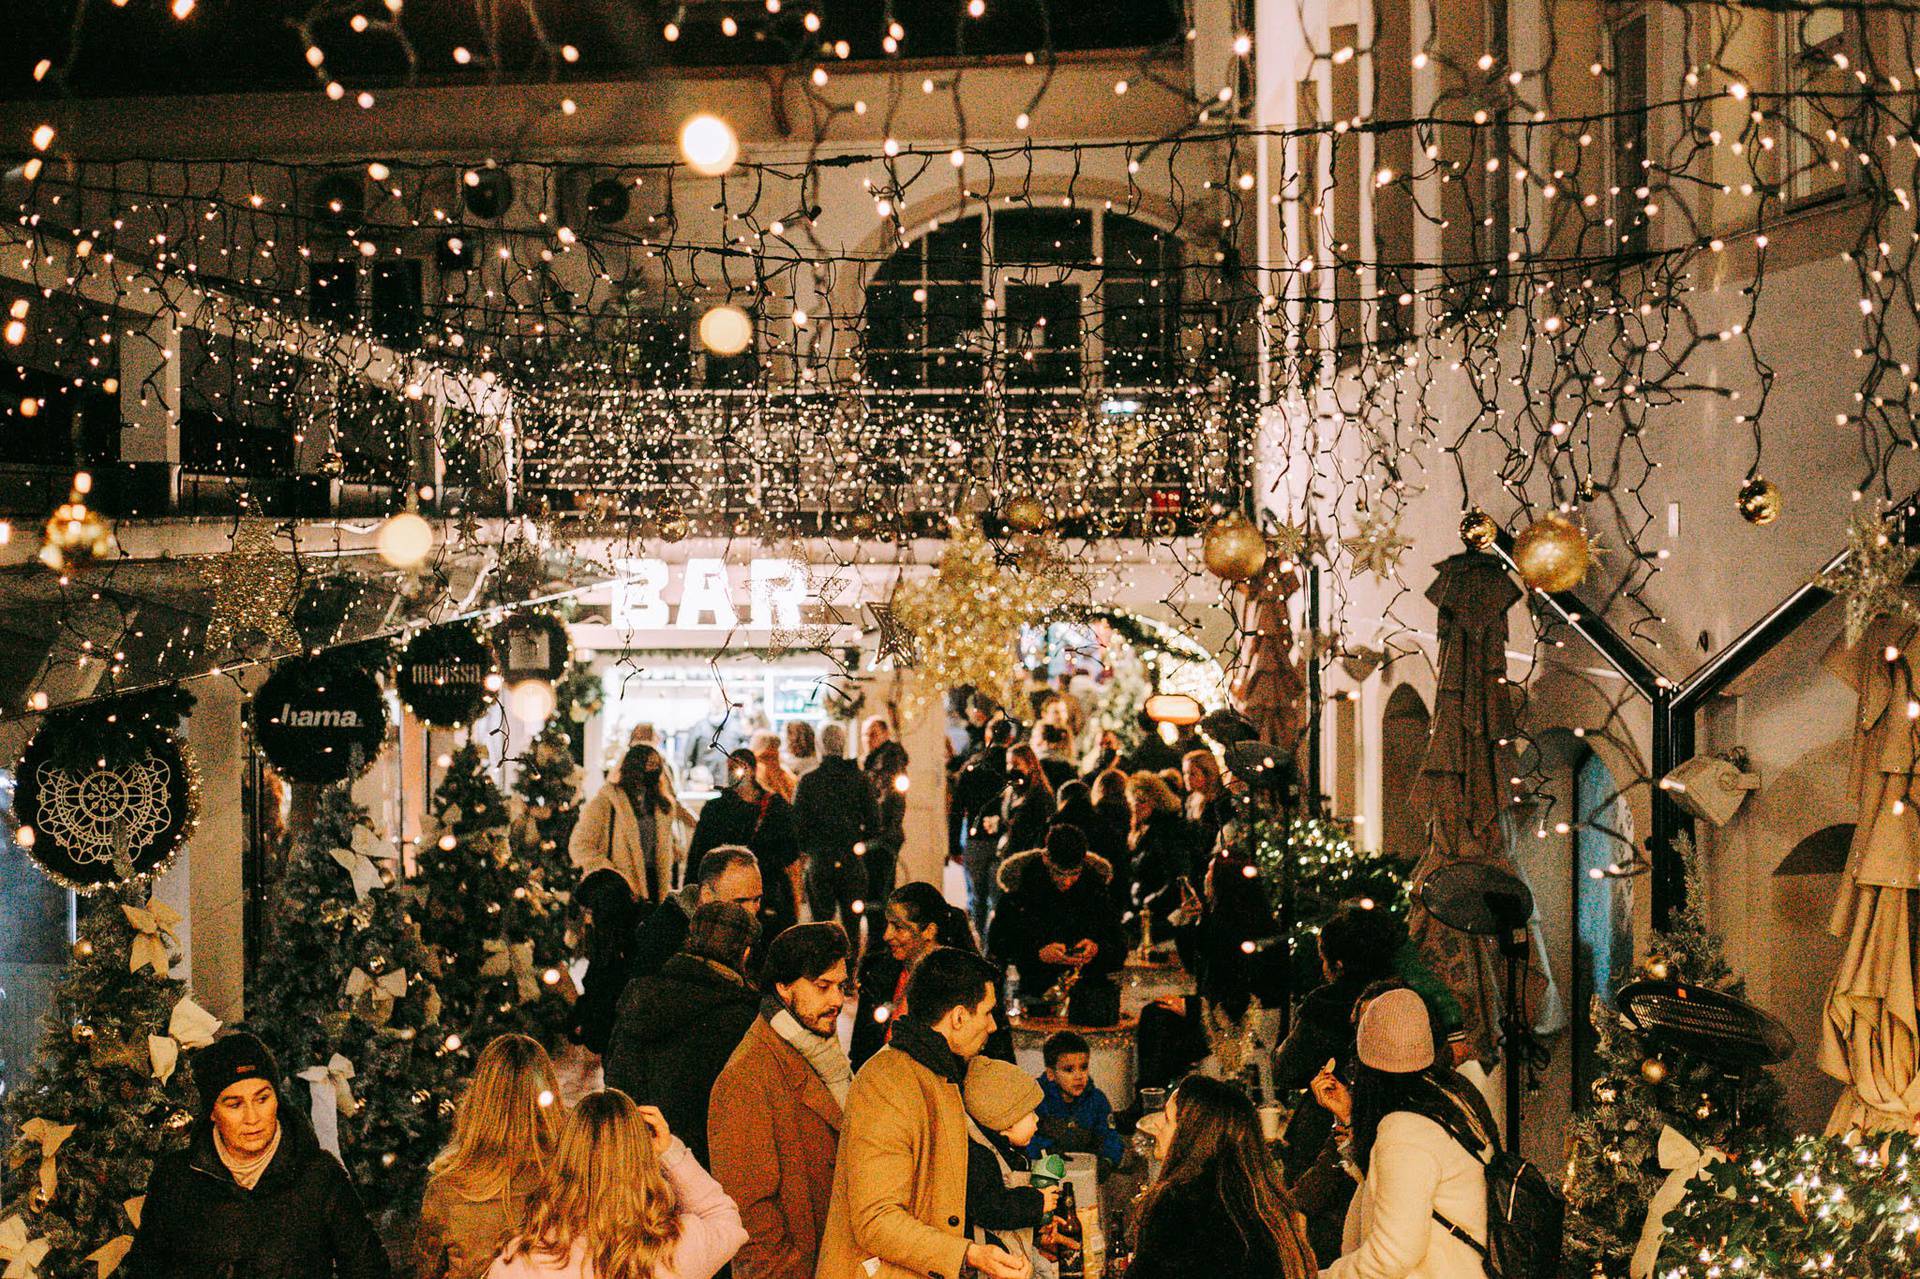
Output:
(814, 947), (1031, 1279)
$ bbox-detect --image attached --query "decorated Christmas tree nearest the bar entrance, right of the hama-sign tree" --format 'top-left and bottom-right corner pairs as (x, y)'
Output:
(419, 743), (572, 1045)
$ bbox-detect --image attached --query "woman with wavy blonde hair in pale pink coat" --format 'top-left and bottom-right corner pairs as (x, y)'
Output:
(486, 1089), (747, 1279)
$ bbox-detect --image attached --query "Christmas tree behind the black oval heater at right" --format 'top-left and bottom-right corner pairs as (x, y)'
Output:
(1567, 843), (1784, 1279)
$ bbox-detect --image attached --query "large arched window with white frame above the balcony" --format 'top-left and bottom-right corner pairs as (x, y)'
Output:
(866, 209), (1181, 390)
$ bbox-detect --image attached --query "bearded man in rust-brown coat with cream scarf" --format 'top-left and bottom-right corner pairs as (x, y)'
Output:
(707, 924), (852, 1279)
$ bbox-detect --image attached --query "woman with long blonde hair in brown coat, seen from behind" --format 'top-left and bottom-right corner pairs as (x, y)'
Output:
(415, 1035), (561, 1279)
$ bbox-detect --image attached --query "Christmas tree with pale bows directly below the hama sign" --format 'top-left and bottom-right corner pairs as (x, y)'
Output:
(248, 785), (458, 1216)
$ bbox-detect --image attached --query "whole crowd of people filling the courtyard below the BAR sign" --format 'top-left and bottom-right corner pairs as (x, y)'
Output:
(127, 675), (1498, 1279)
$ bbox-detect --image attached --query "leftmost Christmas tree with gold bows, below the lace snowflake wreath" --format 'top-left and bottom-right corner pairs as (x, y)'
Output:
(0, 887), (198, 1279)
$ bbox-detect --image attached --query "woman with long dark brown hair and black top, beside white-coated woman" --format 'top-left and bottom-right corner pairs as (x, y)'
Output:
(1127, 1075), (1317, 1279)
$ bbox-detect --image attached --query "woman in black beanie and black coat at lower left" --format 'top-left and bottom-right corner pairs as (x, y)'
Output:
(121, 1033), (392, 1279)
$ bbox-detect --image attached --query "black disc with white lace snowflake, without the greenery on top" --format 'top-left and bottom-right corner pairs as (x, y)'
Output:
(13, 720), (200, 893)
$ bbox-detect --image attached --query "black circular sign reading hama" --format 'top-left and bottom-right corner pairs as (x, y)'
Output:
(253, 657), (386, 784)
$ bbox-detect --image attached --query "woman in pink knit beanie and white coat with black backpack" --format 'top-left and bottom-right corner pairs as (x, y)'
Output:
(1313, 989), (1494, 1279)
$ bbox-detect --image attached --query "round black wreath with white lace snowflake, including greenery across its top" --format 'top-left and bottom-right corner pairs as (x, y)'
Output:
(13, 684), (200, 893)
